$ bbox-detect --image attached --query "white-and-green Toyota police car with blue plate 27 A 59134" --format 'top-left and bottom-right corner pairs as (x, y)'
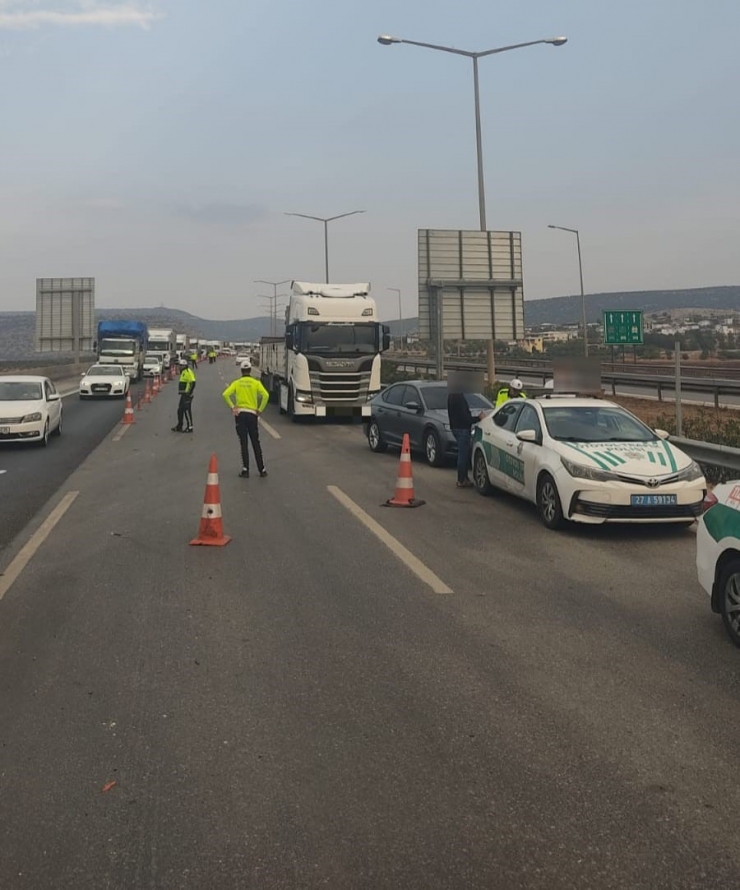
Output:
(472, 396), (707, 529)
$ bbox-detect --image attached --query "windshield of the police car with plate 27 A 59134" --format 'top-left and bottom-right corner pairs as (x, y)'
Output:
(543, 405), (657, 442)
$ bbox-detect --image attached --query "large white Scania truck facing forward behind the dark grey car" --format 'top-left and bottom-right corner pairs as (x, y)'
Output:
(260, 281), (390, 419)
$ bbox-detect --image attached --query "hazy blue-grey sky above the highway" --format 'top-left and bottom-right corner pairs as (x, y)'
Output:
(0, 0), (740, 318)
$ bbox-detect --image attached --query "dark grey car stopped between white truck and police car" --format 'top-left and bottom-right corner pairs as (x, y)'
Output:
(365, 380), (493, 467)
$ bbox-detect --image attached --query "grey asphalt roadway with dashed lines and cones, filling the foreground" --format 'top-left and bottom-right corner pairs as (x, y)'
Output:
(0, 362), (740, 890)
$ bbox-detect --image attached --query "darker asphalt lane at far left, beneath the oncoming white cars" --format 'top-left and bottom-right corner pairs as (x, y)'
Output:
(0, 383), (130, 558)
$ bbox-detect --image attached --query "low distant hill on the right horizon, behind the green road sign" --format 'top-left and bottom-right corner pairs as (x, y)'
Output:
(524, 285), (740, 326)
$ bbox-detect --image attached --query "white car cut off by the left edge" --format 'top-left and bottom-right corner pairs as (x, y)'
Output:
(0, 376), (62, 446)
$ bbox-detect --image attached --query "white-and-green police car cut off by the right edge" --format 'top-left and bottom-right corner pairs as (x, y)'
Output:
(696, 481), (740, 646)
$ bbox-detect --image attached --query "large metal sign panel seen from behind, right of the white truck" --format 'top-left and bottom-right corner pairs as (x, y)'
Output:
(418, 229), (524, 379)
